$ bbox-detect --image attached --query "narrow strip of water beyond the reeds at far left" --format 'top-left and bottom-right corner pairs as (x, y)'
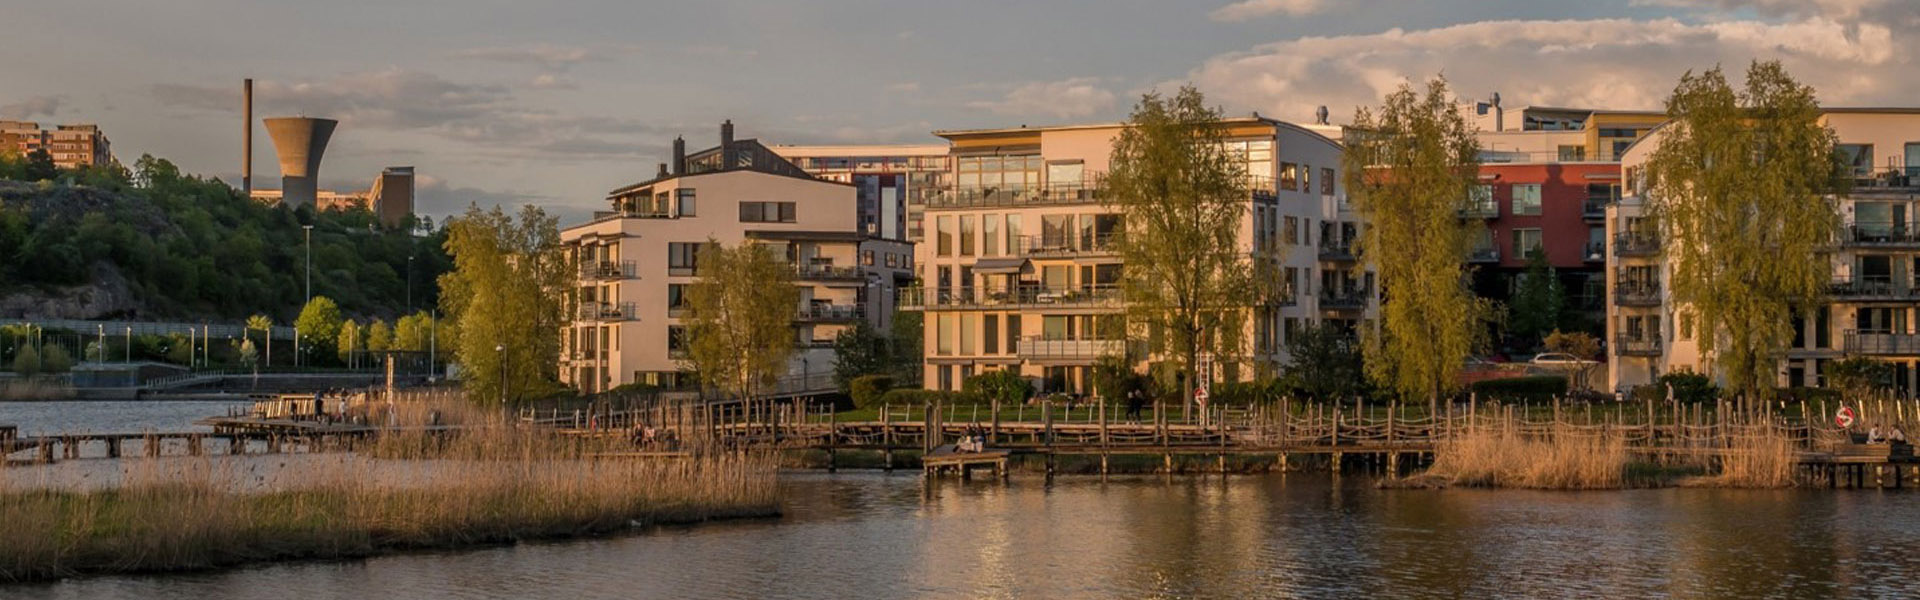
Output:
(0, 400), (252, 437)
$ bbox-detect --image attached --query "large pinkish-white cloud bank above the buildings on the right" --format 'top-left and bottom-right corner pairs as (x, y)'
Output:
(1185, 17), (1920, 121)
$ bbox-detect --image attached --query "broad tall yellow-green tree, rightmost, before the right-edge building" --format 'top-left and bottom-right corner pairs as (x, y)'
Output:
(1645, 62), (1845, 400)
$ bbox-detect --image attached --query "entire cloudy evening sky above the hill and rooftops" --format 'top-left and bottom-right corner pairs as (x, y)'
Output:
(0, 0), (1920, 223)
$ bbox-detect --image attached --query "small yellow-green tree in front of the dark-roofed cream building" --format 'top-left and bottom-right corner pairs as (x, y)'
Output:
(682, 240), (801, 398)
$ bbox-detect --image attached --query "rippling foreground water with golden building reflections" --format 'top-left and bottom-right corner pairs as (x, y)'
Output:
(15, 473), (1920, 600)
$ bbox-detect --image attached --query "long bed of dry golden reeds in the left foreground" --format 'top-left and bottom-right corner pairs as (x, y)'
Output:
(0, 427), (778, 581)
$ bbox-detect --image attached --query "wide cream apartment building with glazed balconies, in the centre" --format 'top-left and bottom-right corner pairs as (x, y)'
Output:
(900, 115), (1379, 392)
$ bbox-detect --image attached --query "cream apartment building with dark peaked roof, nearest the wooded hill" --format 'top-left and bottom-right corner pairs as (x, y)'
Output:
(561, 121), (912, 392)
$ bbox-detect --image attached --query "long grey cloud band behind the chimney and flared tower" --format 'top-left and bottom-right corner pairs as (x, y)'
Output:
(154, 67), (659, 160)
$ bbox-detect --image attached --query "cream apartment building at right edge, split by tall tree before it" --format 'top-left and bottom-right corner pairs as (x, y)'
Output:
(1607, 108), (1920, 396)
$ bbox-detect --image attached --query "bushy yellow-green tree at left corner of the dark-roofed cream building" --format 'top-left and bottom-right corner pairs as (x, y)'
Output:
(440, 204), (578, 402)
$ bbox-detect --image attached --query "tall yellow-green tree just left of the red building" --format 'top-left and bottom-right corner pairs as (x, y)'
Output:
(1342, 79), (1492, 402)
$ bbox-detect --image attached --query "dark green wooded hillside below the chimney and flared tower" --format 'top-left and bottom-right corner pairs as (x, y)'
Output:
(0, 156), (451, 321)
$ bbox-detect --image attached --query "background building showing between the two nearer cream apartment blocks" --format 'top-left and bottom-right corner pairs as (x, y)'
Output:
(772, 144), (952, 242)
